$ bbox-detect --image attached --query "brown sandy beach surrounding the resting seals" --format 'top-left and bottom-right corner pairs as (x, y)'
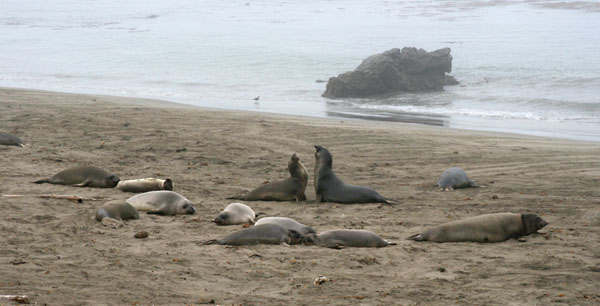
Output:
(0, 89), (600, 305)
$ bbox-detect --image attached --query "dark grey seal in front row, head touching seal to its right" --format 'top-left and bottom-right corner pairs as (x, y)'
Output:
(202, 224), (302, 245)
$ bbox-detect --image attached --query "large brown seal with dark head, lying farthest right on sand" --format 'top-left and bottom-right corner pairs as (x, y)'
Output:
(408, 213), (548, 242)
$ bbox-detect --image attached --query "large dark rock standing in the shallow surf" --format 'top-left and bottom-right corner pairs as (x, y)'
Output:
(323, 48), (452, 98)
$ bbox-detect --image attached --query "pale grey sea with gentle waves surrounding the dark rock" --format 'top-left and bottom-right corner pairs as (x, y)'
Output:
(0, 0), (600, 141)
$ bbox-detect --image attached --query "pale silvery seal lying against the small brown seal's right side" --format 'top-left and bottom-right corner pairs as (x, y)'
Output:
(126, 190), (196, 216)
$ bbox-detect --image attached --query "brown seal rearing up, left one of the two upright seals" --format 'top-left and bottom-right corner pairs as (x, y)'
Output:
(228, 153), (308, 202)
